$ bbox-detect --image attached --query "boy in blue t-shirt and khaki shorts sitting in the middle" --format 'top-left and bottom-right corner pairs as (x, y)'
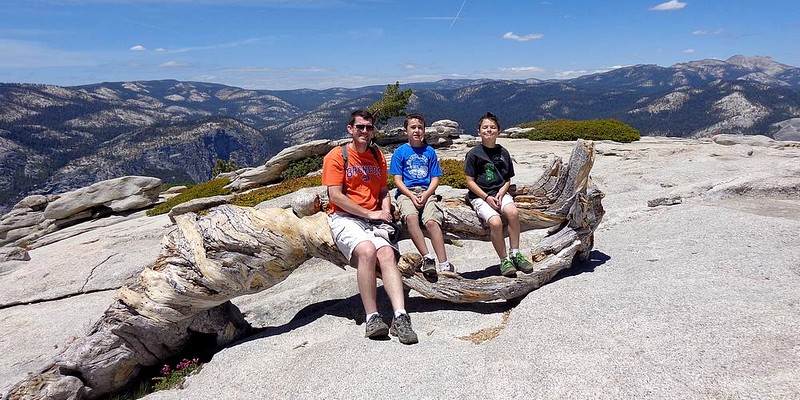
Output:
(389, 114), (456, 275)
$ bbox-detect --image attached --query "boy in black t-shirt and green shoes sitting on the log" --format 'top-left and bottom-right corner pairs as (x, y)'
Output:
(464, 112), (533, 277)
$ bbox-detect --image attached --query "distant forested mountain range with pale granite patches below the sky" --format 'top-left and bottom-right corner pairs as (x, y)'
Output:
(0, 56), (800, 212)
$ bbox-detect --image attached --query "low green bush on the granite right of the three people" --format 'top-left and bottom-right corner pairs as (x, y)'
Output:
(518, 119), (641, 143)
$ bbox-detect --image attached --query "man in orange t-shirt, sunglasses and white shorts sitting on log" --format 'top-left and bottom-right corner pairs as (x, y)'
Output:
(322, 110), (418, 344)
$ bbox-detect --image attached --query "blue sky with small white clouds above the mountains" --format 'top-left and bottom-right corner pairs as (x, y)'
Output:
(0, 0), (800, 89)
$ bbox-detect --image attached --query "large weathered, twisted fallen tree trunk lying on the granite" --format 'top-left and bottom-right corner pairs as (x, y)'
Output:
(8, 141), (603, 399)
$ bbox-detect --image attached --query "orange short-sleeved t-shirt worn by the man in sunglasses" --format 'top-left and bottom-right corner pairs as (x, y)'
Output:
(322, 145), (388, 214)
